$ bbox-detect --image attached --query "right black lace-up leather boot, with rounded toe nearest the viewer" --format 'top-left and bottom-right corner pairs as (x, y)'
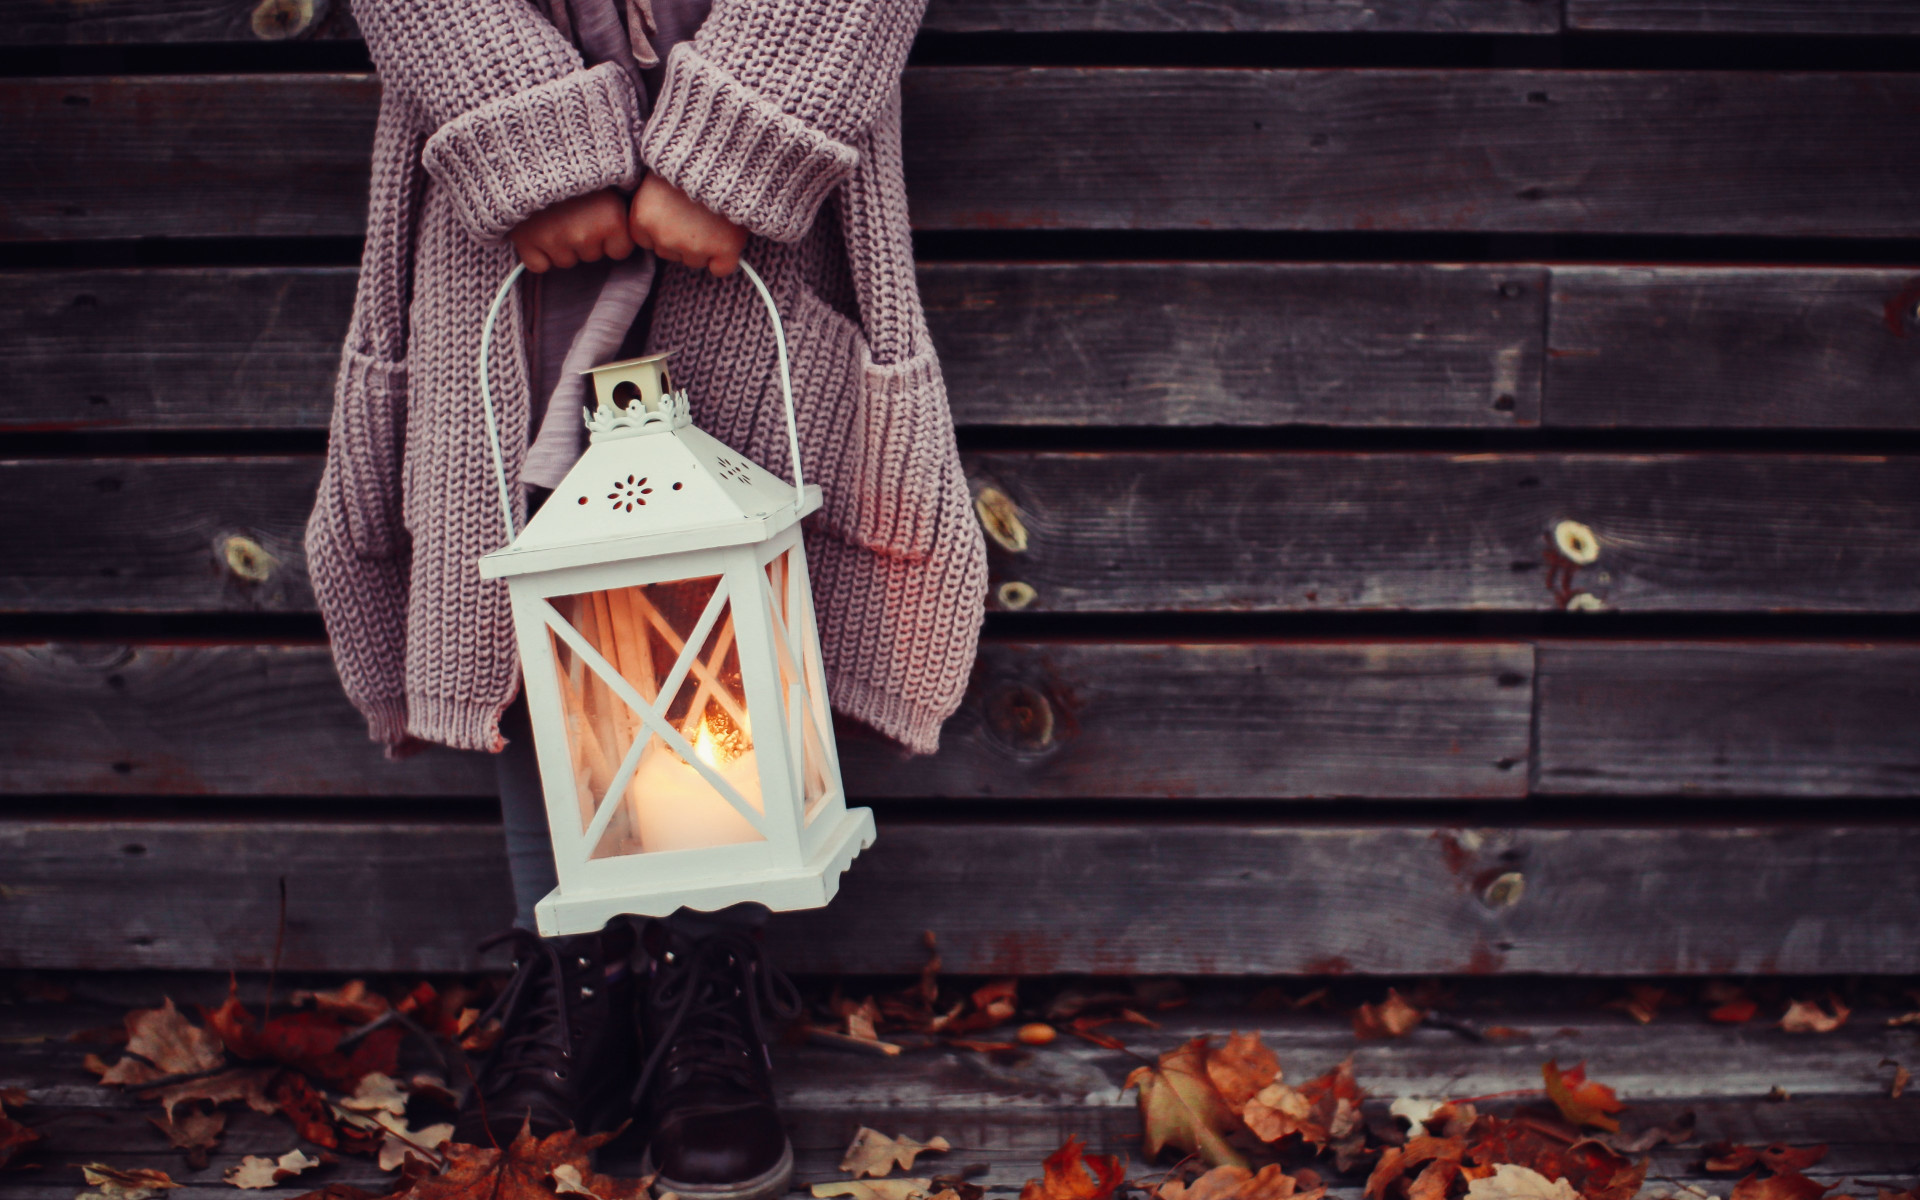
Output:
(634, 922), (801, 1200)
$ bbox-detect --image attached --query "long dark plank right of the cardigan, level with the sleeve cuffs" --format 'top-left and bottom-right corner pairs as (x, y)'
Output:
(904, 67), (1920, 236)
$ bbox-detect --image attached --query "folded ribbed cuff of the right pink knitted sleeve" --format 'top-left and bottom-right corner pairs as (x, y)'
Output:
(639, 42), (860, 242)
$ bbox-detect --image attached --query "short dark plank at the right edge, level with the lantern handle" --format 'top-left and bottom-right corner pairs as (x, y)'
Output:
(1546, 266), (1920, 430)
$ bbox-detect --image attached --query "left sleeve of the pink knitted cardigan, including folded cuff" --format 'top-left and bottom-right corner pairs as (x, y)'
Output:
(353, 0), (639, 242)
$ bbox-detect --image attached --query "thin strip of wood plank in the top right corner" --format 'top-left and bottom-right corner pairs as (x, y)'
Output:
(1565, 0), (1920, 36)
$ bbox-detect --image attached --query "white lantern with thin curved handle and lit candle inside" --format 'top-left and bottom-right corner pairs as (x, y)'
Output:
(480, 263), (874, 937)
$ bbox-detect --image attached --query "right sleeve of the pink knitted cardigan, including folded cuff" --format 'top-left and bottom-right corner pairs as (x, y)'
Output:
(639, 0), (925, 242)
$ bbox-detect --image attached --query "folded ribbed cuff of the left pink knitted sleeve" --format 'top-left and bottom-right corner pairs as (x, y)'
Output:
(420, 63), (639, 240)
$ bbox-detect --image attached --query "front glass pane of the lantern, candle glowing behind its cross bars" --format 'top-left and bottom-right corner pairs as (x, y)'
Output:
(549, 576), (764, 858)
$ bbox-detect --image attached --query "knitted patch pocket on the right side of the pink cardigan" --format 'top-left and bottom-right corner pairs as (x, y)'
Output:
(776, 284), (960, 561)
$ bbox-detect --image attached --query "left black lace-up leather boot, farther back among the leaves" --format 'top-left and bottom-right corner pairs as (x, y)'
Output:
(453, 922), (639, 1146)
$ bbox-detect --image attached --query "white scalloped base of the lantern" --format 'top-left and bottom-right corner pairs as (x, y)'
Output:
(534, 808), (874, 937)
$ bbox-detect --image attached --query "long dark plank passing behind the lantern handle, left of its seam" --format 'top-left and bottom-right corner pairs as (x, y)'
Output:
(0, 263), (1546, 430)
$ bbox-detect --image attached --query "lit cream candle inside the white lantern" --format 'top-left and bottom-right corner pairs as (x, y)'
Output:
(628, 718), (766, 852)
